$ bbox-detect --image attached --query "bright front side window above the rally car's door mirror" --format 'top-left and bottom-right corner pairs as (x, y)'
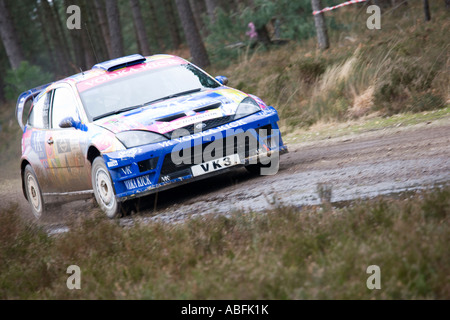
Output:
(52, 88), (80, 129)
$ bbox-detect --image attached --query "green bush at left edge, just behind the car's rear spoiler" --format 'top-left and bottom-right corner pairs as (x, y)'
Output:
(4, 61), (53, 101)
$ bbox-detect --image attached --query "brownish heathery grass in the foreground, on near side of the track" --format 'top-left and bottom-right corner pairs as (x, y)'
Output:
(0, 187), (450, 299)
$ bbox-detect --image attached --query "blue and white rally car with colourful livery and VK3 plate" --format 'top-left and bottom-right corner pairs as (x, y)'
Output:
(16, 55), (287, 218)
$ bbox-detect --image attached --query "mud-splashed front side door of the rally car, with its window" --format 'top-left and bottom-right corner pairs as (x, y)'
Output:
(46, 85), (91, 193)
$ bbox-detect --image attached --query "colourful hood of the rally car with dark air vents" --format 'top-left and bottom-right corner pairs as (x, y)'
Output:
(94, 87), (253, 134)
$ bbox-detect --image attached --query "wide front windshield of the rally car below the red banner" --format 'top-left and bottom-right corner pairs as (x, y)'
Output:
(80, 64), (220, 120)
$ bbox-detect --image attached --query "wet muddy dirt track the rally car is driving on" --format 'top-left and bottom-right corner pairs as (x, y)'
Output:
(0, 119), (450, 227)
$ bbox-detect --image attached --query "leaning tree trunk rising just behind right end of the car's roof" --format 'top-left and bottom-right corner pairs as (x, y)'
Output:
(175, 0), (210, 68)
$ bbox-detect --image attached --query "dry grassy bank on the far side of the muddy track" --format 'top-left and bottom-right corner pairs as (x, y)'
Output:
(206, 2), (450, 132)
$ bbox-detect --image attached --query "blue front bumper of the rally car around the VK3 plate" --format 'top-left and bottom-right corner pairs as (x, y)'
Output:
(103, 107), (287, 201)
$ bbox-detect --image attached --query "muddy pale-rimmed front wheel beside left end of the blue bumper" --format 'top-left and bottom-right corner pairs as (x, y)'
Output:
(91, 157), (122, 219)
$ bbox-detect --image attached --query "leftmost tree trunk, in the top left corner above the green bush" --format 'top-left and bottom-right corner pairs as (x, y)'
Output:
(0, 0), (24, 69)
